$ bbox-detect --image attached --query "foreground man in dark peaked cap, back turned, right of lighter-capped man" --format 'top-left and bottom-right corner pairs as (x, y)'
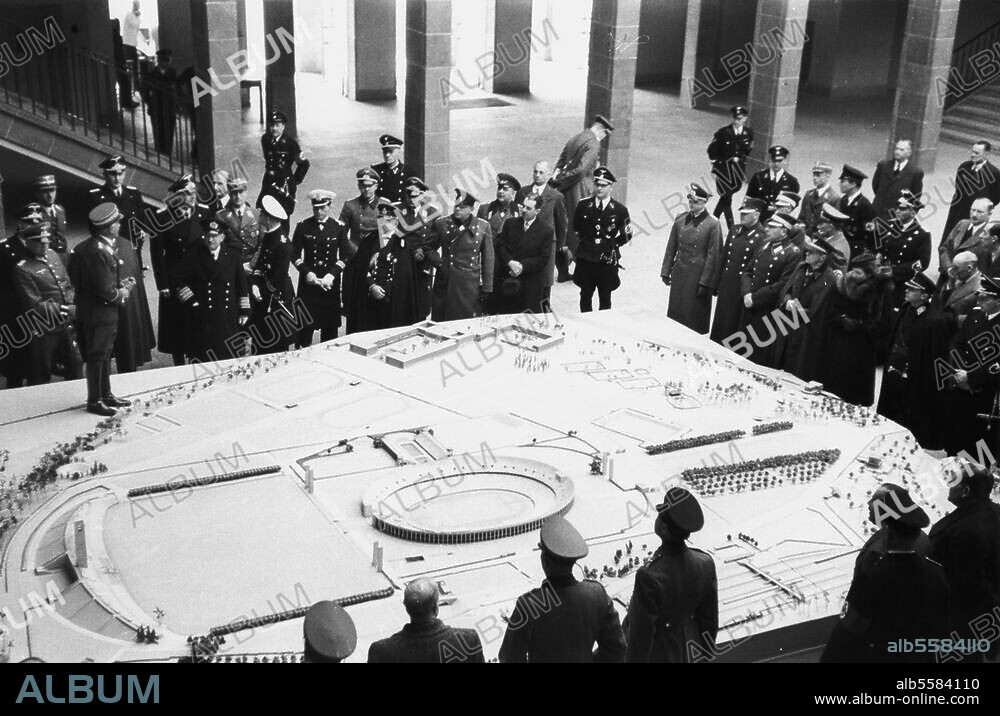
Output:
(625, 487), (719, 663)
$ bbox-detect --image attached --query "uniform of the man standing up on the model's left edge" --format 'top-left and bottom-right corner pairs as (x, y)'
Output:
(70, 236), (121, 403)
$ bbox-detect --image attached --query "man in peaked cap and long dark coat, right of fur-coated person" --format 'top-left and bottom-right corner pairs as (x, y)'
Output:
(878, 273), (951, 450)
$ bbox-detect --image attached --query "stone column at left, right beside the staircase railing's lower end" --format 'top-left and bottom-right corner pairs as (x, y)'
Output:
(191, 0), (243, 174)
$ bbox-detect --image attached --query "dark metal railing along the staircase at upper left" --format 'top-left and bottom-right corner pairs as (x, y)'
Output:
(0, 12), (197, 174)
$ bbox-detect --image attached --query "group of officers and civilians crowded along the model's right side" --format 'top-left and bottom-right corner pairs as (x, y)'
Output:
(660, 107), (1000, 464)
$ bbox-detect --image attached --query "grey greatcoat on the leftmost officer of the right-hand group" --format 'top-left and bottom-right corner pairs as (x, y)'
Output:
(660, 211), (722, 333)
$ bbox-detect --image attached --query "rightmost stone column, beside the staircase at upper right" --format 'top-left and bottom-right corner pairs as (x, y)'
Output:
(889, 0), (960, 172)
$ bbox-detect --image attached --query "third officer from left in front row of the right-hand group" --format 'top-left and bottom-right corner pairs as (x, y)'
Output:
(741, 208), (802, 367)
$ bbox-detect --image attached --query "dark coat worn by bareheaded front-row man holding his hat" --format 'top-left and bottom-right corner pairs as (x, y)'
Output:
(493, 216), (555, 313)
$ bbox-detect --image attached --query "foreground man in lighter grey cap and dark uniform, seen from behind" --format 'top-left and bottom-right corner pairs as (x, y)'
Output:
(499, 515), (625, 663)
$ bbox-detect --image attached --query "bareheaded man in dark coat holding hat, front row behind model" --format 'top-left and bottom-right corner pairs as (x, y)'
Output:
(494, 194), (555, 313)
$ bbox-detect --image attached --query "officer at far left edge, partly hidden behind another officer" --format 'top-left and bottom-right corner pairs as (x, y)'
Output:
(0, 203), (43, 388)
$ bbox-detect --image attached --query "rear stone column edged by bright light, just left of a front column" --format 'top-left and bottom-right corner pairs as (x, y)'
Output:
(347, 0), (396, 102)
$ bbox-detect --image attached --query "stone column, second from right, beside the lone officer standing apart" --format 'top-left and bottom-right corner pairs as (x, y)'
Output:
(747, 0), (809, 176)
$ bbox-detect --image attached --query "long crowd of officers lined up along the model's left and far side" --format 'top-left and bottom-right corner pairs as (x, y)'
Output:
(0, 111), (631, 416)
